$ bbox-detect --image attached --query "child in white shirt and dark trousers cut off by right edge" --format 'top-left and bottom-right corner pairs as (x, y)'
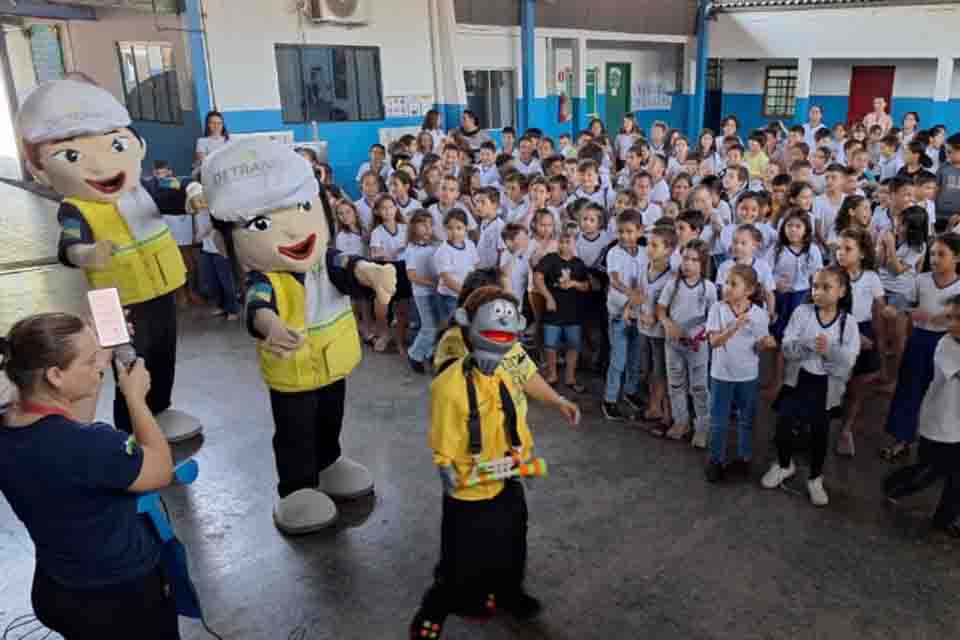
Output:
(883, 295), (960, 538)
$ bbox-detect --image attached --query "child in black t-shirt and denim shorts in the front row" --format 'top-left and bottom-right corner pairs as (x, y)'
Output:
(534, 230), (590, 393)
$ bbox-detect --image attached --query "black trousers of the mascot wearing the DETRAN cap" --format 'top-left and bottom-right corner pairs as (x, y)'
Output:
(270, 380), (347, 498)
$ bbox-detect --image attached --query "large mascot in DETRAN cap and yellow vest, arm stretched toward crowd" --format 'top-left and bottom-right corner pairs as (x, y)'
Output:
(201, 140), (397, 534)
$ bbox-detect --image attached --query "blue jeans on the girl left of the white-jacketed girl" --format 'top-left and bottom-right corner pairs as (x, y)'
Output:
(710, 377), (760, 464)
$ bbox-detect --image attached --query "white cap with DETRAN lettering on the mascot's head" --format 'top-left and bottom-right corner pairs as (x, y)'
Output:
(200, 139), (320, 222)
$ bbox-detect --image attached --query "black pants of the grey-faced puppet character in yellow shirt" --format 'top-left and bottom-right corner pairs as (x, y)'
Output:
(419, 480), (527, 624)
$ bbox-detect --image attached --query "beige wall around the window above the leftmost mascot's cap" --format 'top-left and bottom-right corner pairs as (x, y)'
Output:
(64, 9), (193, 111)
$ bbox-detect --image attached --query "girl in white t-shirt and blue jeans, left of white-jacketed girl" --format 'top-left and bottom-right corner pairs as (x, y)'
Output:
(706, 264), (777, 482)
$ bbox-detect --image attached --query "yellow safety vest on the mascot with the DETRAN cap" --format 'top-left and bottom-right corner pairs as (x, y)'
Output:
(257, 271), (361, 393)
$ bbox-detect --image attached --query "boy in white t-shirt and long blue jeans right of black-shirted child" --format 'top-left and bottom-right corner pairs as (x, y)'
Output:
(603, 210), (647, 421)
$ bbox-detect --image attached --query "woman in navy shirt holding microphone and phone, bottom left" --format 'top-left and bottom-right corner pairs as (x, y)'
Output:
(0, 313), (180, 640)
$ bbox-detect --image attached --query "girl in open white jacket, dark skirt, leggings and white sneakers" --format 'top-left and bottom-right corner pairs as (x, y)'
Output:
(761, 265), (860, 507)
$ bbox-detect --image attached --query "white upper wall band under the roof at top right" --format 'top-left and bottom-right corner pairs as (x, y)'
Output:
(710, 4), (960, 60)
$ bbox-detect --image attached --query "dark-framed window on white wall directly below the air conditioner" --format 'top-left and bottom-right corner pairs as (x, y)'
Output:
(276, 44), (384, 123)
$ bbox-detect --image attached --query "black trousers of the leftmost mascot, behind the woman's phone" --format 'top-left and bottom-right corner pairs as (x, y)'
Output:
(113, 291), (177, 433)
